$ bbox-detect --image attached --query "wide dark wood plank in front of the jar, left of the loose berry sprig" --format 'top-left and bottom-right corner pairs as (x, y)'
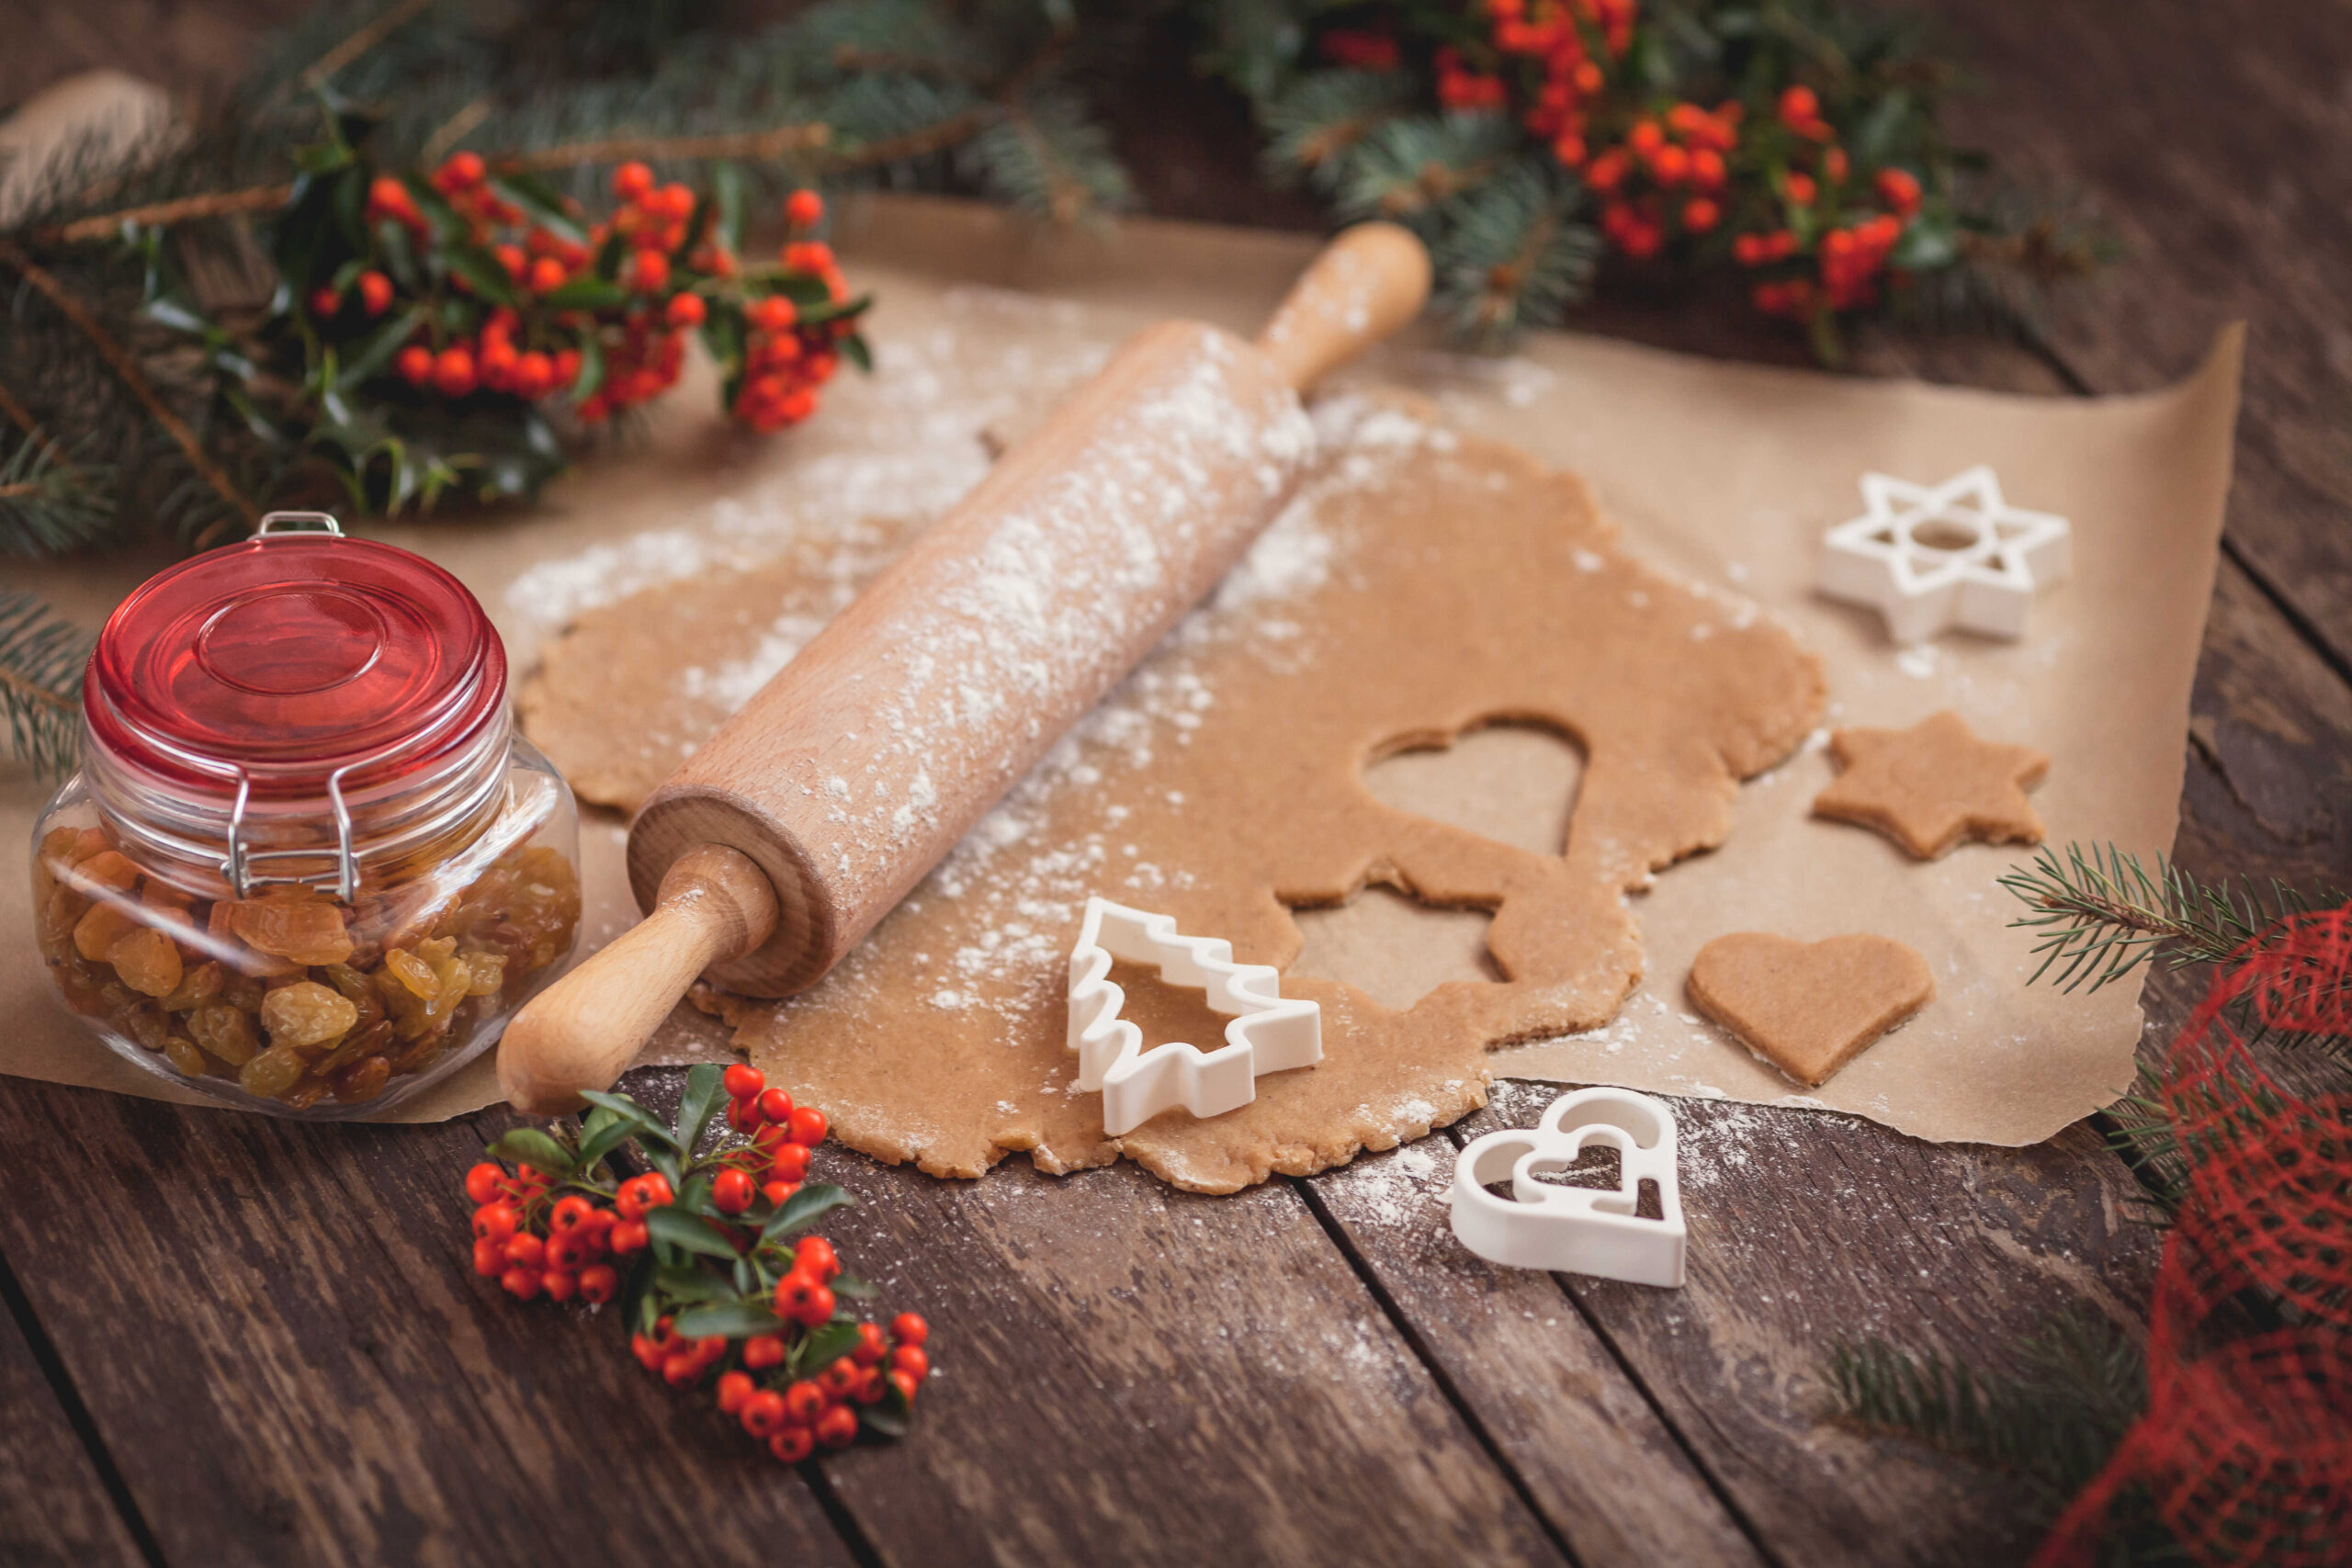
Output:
(0, 1079), (852, 1565)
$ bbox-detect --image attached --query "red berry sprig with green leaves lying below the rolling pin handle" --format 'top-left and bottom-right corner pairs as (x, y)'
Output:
(448, 1063), (932, 1464)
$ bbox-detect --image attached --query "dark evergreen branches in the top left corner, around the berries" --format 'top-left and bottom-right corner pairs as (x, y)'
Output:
(0, 0), (1129, 558)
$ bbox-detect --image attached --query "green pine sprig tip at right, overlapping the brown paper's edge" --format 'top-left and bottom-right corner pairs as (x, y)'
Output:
(1999, 844), (2343, 989)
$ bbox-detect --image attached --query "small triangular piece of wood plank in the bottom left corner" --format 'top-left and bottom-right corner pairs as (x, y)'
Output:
(0, 1279), (141, 1568)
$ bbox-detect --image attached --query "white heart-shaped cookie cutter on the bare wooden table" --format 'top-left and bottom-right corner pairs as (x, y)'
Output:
(1446, 1089), (1689, 1286)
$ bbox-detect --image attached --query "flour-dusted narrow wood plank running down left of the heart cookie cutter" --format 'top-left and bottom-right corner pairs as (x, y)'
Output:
(1306, 1138), (1761, 1568)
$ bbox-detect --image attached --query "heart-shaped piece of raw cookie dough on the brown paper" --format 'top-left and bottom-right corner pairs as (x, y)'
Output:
(1691, 931), (1936, 1089)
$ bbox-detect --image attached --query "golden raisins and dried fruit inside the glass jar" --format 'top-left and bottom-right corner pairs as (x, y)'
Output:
(33, 828), (581, 1110)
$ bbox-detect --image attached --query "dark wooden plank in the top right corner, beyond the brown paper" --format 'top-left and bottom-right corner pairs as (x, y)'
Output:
(1927, 0), (2352, 670)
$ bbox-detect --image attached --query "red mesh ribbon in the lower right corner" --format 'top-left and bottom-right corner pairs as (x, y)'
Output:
(2034, 908), (2352, 1568)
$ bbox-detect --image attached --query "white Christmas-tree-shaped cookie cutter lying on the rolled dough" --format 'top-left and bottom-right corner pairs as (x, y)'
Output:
(1068, 898), (1322, 1138)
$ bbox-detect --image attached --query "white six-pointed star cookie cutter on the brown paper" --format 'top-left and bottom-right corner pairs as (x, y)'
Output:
(1818, 466), (2075, 642)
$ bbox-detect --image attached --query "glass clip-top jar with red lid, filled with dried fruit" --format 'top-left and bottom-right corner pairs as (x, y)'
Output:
(33, 513), (581, 1119)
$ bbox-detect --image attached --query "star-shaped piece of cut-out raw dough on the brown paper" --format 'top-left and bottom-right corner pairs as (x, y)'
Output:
(1814, 710), (2051, 861)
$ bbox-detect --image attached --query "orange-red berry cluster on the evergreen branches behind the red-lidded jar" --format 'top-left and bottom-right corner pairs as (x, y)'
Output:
(308, 152), (856, 433)
